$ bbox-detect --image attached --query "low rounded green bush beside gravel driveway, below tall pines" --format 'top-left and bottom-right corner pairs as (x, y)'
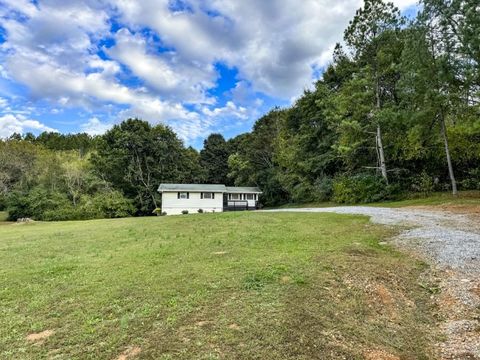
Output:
(333, 175), (399, 204)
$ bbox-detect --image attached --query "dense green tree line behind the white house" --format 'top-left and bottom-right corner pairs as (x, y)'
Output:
(0, 0), (480, 220)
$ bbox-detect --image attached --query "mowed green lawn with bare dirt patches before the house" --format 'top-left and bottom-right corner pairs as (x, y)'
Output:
(0, 213), (435, 359)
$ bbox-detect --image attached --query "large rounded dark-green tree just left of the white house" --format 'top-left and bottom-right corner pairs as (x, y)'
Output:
(92, 119), (190, 215)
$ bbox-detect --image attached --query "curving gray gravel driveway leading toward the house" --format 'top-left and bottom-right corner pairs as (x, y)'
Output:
(264, 206), (480, 360)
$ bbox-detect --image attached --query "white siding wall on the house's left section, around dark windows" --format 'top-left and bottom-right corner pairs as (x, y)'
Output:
(162, 192), (223, 215)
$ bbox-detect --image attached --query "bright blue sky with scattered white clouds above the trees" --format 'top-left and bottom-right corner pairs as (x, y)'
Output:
(0, 0), (416, 148)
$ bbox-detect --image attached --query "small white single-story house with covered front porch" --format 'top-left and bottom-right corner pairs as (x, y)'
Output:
(158, 184), (262, 215)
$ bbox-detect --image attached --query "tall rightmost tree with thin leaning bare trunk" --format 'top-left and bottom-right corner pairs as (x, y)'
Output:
(403, 1), (469, 195)
